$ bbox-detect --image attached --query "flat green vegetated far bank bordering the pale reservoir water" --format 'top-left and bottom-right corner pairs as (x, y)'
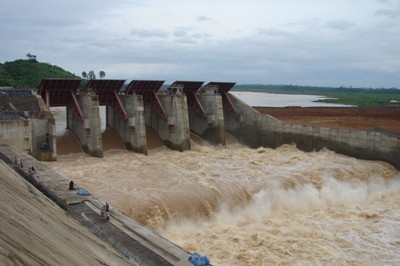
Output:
(233, 84), (400, 107)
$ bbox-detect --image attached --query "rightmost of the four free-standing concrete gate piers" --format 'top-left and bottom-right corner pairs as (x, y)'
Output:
(189, 93), (225, 146)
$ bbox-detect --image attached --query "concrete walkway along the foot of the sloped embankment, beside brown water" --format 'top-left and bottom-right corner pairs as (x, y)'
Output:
(0, 143), (191, 266)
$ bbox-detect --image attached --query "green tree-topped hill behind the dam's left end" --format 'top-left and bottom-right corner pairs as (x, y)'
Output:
(0, 59), (79, 89)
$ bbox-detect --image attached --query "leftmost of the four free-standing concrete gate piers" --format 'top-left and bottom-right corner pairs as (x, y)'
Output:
(67, 92), (103, 158)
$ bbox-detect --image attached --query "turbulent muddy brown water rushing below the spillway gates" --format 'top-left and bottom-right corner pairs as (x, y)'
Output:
(46, 107), (400, 265)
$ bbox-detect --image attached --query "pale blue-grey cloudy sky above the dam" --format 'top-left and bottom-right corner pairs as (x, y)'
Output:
(0, 0), (400, 88)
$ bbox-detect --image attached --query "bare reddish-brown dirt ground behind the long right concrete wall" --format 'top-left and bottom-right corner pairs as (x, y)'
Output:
(255, 107), (400, 134)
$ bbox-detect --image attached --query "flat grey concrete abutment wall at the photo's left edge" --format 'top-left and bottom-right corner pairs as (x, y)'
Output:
(0, 120), (32, 154)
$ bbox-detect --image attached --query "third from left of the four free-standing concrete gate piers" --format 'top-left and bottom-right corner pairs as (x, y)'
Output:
(145, 94), (191, 151)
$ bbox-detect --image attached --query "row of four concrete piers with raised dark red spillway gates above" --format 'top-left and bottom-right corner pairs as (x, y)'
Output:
(39, 79), (228, 157)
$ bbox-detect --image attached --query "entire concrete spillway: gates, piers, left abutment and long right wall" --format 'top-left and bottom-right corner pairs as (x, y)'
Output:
(0, 79), (400, 169)
